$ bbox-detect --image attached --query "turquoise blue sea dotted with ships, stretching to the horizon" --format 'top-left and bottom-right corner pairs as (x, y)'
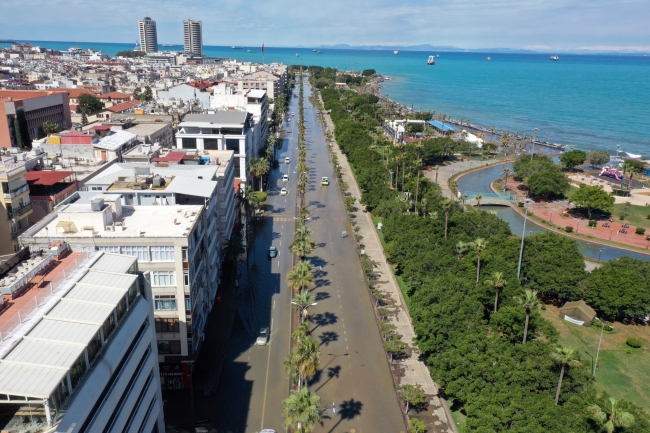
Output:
(5, 41), (650, 156)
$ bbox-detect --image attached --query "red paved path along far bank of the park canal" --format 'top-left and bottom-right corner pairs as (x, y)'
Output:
(507, 179), (649, 249)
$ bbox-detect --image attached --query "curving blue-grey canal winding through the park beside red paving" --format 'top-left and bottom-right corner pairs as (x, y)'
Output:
(457, 164), (650, 261)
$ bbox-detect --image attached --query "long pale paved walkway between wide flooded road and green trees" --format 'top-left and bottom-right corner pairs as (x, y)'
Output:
(318, 94), (456, 433)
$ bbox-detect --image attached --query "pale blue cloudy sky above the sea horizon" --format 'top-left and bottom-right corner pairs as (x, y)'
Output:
(0, 0), (650, 52)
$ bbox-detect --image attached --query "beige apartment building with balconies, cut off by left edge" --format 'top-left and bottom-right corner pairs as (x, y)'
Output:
(0, 162), (32, 255)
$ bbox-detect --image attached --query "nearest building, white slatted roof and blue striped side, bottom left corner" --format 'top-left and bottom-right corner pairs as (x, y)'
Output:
(0, 248), (165, 433)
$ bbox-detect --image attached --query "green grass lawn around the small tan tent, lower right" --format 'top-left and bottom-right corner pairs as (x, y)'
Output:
(540, 306), (650, 413)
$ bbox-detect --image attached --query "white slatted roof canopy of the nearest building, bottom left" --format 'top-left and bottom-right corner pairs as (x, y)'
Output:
(0, 253), (137, 399)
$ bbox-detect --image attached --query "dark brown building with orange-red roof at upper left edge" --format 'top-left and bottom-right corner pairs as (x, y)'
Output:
(0, 90), (72, 147)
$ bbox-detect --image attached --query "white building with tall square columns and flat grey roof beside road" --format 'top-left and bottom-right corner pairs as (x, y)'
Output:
(176, 110), (266, 183)
